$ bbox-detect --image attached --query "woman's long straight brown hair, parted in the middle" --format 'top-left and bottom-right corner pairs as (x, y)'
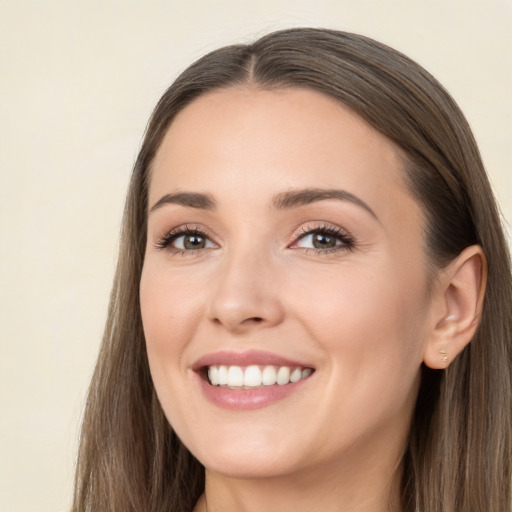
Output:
(73, 28), (512, 512)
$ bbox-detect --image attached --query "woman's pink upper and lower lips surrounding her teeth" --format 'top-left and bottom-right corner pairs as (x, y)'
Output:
(192, 350), (315, 411)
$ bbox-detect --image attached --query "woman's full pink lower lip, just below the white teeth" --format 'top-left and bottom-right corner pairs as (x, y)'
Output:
(197, 374), (311, 411)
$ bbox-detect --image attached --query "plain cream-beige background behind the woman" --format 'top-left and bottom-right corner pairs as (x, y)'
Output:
(0, 0), (512, 512)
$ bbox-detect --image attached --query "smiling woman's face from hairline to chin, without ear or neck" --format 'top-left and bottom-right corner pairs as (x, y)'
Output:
(140, 87), (440, 477)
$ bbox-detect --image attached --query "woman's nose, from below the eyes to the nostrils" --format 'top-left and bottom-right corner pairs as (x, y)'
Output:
(208, 252), (284, 334)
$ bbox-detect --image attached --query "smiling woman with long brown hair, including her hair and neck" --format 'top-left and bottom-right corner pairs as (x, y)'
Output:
(74, 29), (512, 512)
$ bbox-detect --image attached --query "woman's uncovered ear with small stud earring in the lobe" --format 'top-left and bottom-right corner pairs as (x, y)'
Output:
(423, 245), (487, 369)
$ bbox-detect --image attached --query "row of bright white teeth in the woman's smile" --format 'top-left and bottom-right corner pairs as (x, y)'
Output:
(204, 365), (313, 388)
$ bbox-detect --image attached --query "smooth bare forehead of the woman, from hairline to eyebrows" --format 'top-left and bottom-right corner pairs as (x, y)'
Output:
(150, 86), (415, 222)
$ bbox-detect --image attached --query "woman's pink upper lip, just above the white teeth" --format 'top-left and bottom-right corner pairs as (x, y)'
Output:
(192, 350), (313, 371)
